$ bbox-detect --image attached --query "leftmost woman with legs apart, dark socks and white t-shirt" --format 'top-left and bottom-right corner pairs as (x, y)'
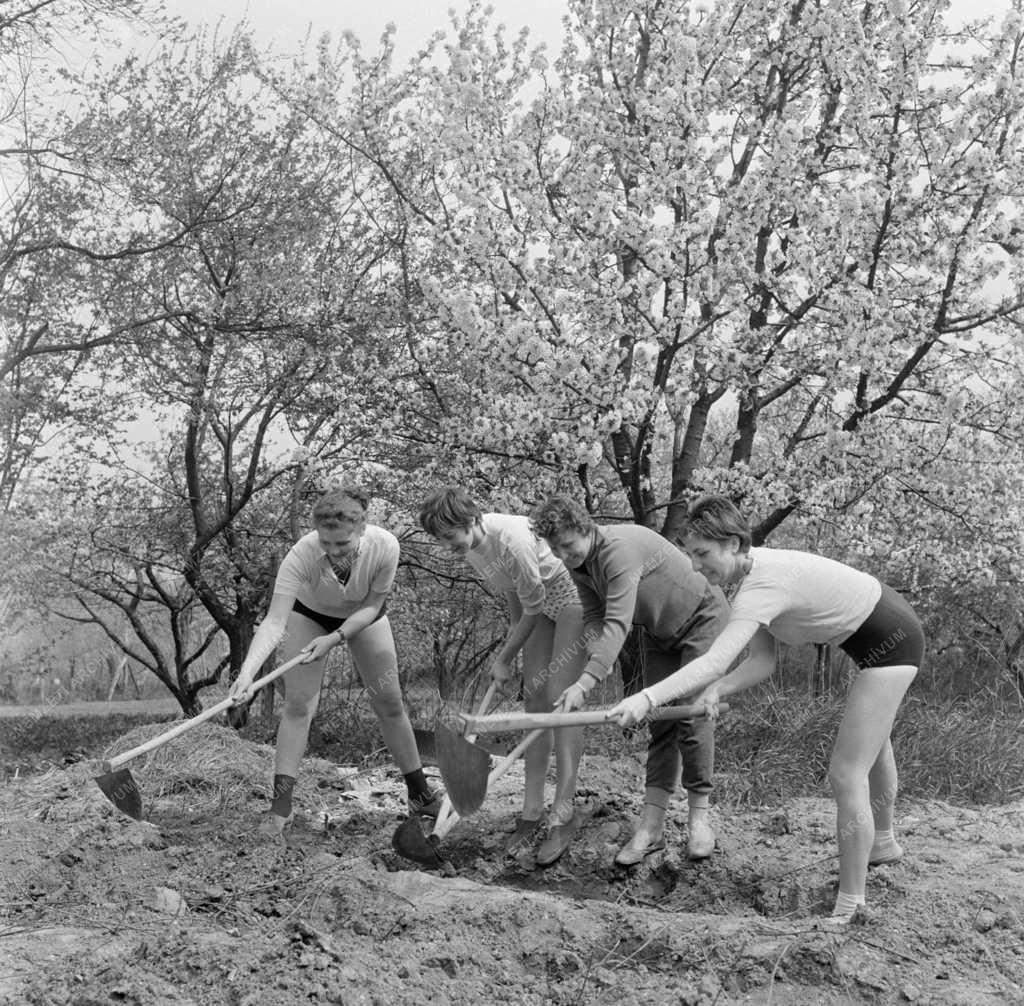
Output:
(231, 486), (439, 835)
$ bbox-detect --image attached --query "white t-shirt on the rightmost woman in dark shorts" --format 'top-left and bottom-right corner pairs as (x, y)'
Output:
(729, 548), (882, 643)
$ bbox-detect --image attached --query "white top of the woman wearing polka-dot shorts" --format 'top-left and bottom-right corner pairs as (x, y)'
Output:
(466, 513), (568, 615)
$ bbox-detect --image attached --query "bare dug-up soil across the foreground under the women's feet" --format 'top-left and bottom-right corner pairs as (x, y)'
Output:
(0, 726), (1024, 1006)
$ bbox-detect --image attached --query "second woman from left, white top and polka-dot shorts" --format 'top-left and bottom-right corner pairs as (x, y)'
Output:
(420, 487), (587, 866)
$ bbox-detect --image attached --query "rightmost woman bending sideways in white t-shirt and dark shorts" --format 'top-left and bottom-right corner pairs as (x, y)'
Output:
(608, 496), (925, 922)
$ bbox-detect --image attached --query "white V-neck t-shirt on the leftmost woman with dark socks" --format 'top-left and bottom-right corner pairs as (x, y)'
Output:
(273, 523), (398, 619)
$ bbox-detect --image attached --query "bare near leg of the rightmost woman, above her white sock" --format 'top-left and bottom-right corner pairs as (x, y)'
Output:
(828, 667), (918, 898)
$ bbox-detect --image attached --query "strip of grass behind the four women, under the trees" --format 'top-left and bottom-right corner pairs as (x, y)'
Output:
(6, 684), (1024, 806)
